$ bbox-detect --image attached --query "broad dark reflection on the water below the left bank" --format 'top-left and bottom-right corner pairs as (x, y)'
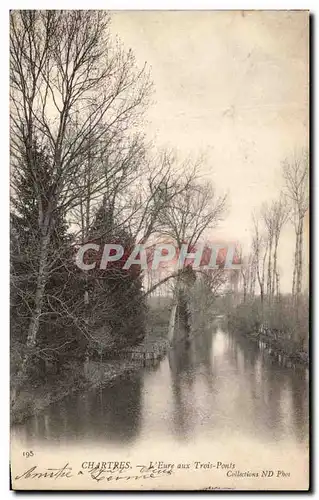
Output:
(16, 372), (142, 443)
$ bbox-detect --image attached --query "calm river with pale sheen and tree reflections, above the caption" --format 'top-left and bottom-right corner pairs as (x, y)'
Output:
(12, 321), (309, 488)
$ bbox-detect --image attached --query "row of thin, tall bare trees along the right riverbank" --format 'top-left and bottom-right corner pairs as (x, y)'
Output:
(229, 149), (309, 356)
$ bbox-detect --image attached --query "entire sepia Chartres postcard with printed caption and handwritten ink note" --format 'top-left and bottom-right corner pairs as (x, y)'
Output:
(10, 10), (310, 491)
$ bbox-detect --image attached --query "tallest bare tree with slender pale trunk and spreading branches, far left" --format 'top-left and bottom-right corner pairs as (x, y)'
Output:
(10, 10), (150, 370)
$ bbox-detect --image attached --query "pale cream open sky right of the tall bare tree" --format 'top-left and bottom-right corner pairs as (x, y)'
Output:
(112, 11), (309, 291)
